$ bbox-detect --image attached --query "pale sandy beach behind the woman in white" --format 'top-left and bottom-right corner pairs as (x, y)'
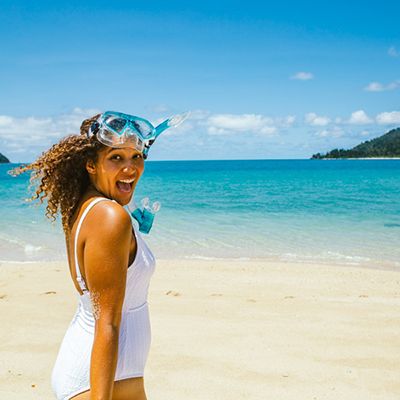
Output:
(0, 260), (400, 400)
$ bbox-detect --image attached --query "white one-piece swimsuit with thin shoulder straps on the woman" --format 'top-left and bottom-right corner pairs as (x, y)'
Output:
(51, 197), (155, 400)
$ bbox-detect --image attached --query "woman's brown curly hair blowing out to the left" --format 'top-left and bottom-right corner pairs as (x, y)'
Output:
(10, 114), (105, 236)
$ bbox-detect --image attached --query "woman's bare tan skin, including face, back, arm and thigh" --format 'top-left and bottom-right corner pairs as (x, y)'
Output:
(67, 147), (146, 400)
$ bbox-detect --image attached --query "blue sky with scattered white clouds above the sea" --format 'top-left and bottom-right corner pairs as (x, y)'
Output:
(0, 0), (400, 161)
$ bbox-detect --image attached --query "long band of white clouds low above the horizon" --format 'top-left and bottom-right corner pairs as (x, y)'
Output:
(0, 108), (400, 161)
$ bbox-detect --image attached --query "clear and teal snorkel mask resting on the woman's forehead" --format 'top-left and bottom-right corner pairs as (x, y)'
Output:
(87, 111), (189, 159)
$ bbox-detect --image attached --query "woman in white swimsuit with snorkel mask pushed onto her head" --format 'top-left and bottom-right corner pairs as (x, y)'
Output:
(16, 112), (187, 400)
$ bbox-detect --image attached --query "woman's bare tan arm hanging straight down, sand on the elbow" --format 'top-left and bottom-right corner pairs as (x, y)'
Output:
(84, 201), (132, 400)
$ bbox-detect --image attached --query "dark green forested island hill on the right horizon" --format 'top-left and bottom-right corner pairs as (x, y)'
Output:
(311, 128), (400, 160)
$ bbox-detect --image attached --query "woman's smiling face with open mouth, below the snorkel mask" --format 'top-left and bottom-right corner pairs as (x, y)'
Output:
(86, 147), (144, 205)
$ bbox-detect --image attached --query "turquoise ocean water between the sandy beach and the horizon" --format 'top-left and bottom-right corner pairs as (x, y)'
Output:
(0, 160), (400, 269)
